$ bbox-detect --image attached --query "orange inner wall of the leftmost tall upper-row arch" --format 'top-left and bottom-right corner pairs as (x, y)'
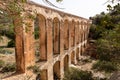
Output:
(37, 14), (47, 61)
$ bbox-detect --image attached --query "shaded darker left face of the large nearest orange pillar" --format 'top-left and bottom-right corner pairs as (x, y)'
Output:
(14, 16), (25, 73)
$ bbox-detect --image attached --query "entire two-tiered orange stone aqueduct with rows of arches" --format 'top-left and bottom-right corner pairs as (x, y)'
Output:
(4, 2), (91, 80)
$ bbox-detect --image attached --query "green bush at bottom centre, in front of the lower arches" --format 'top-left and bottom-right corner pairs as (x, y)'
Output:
(63, 68), (94, 80)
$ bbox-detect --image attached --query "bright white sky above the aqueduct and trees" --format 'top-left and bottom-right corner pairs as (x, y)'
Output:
(32, 0), (112, 18)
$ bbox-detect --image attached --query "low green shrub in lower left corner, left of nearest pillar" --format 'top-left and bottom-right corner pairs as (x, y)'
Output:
(1, 63), (16, 73)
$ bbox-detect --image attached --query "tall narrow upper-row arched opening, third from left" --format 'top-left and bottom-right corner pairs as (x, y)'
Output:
(64, 20), (69, 50)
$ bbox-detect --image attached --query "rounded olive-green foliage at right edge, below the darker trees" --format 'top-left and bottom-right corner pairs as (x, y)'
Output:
(96, 28), (120, 62)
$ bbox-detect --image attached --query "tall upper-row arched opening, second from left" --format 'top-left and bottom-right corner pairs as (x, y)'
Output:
(53, 18), (60, 54)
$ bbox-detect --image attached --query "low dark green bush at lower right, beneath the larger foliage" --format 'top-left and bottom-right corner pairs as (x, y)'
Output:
(92, 61), (117, 72)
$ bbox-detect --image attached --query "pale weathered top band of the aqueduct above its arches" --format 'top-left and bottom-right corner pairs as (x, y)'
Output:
(26, 1), (91, 23)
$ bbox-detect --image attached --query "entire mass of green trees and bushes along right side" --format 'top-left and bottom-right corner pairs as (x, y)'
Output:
(90, 3), (120, 72)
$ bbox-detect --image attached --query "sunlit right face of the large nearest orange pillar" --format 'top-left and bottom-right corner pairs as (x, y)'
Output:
(24, 14), (35, 68)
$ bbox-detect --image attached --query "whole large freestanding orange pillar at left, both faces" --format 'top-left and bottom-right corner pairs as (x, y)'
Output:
(14, 13), (35, 72)
